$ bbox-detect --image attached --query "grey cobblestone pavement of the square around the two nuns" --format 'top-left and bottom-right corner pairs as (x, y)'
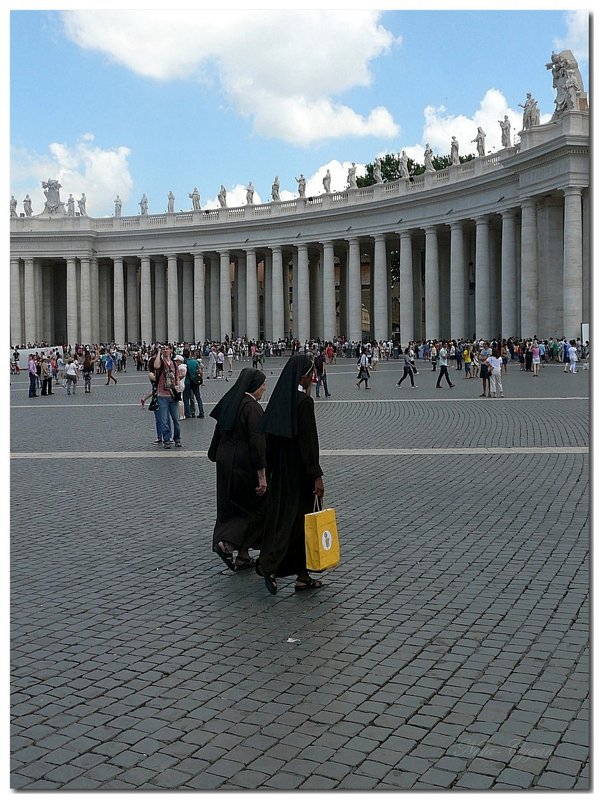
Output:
(10, 359), (590, 791)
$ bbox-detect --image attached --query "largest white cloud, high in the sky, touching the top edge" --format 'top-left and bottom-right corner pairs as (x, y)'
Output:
(63, 9), (399, 146)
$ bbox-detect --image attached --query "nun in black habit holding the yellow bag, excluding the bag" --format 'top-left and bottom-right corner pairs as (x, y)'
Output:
(256, 355), (324, 594)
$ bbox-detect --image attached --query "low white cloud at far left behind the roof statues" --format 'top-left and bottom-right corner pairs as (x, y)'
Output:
(11, 133), (133, 217)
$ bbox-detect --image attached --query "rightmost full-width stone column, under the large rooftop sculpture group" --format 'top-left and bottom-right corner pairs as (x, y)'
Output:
(562, 186), (583, 339)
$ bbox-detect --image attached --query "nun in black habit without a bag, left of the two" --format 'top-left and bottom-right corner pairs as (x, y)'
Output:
(208, 367), (267, 572)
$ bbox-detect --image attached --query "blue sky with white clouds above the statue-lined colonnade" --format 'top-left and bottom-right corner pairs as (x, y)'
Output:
(9, 4), (589, 216)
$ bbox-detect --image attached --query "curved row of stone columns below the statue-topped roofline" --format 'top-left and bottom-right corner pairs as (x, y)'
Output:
(10, 187), (589, 344)
